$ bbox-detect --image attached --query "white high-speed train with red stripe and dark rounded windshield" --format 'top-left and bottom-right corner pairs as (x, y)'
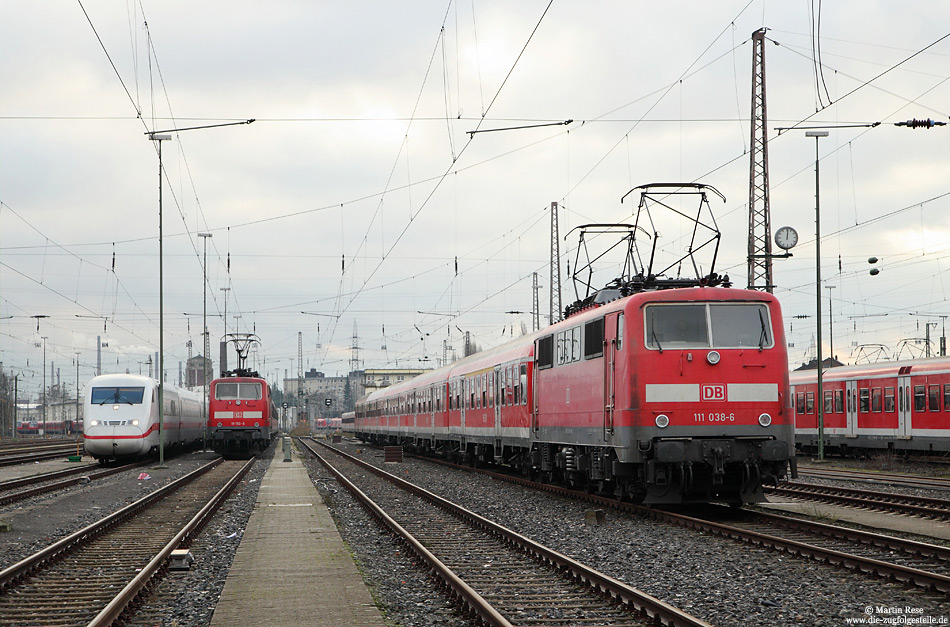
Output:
(83, 374), (205, 462)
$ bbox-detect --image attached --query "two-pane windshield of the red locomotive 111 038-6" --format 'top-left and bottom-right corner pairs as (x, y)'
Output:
(645, 302), (773, 350)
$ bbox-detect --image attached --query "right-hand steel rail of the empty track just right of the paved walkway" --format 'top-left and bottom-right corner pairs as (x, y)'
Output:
(302, 442), (709, 627)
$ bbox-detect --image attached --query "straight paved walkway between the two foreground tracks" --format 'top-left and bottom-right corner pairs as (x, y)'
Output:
(211, 447), (386, 627)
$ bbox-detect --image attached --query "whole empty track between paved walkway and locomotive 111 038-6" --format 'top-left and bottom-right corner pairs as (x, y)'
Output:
(300, 441), (708, 627)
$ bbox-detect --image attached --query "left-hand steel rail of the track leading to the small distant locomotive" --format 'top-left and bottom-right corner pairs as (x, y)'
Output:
(0, 457), (223, 590)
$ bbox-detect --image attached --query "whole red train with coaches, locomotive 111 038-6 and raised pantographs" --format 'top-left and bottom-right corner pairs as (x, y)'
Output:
(355, 184), (795, 503)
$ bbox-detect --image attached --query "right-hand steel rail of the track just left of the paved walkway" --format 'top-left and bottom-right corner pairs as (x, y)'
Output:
(86, 457), (257, 627)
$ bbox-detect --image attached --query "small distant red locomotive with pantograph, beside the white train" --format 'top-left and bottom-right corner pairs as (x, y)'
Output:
(208, 333), (277, 457)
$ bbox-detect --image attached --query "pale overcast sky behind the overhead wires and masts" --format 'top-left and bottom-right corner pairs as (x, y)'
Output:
(0, 0), (950, 394)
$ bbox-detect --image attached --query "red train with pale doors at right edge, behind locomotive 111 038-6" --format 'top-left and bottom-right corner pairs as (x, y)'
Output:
(789, 357), (950, 455)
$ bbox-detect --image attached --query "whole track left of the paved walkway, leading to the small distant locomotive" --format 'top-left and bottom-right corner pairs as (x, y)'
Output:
(0, 459), (254, 627)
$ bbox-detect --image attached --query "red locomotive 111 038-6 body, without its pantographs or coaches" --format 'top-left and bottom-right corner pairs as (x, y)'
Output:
(552, 287), (793, 503)
